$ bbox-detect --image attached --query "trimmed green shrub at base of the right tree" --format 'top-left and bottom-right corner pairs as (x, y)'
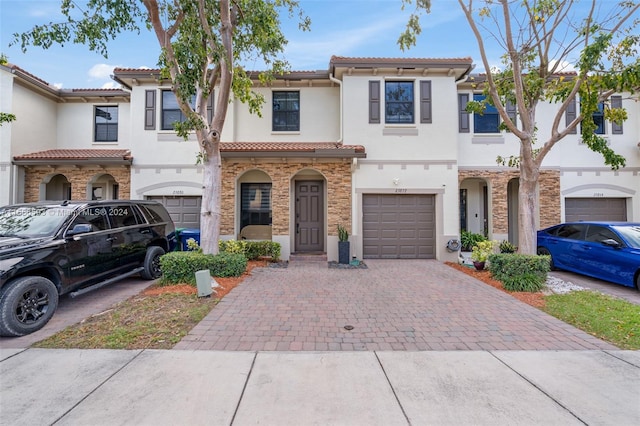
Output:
(489, 253), (551, 292)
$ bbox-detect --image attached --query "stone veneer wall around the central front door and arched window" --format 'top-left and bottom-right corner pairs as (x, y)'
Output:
(220, 159), (351, 235)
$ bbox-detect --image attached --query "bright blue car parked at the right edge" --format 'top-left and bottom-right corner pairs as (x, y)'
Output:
(538, 222), (640, 290)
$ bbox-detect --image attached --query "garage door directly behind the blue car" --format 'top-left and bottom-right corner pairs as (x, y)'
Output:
(564, 198), (627, 222)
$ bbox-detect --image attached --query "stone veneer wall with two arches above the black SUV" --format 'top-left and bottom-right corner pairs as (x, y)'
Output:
(24, 166), (131, 203)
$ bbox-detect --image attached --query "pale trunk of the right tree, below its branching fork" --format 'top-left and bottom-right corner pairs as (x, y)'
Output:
(518, 161), (540, 254)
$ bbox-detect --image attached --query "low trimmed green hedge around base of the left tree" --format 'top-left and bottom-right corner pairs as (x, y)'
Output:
(160, 251), (247, 285)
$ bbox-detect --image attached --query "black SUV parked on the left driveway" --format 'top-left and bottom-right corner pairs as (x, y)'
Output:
(0, 200), (176, 336)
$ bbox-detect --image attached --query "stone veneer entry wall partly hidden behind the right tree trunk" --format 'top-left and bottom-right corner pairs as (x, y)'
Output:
(458, 170), (561, 234)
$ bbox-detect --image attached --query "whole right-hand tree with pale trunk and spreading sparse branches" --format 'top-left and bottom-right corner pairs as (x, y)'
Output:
(398, 0), (640, 253)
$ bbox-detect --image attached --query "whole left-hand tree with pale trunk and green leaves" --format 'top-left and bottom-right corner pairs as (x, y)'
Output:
(14, 0), (310, 253)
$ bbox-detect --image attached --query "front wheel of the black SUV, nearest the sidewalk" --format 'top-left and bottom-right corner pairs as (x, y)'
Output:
(0, 277), (58, 337)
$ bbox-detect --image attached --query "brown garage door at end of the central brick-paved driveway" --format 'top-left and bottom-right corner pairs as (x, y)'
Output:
(362, 194), (435, 259)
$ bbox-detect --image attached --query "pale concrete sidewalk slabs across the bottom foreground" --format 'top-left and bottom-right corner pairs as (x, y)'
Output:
(0, 349), (640, 426)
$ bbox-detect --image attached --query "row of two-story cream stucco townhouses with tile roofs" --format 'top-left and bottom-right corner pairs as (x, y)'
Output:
(0, 56), (640, 261)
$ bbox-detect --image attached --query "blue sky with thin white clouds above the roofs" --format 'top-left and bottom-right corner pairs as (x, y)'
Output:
(0, 0), (488, 89)
